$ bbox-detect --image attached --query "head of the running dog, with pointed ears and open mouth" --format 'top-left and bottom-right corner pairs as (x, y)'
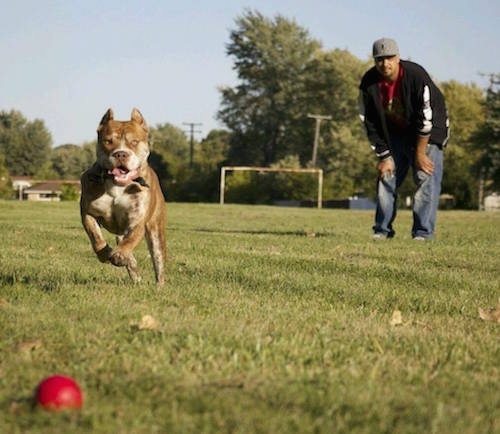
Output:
(96, 108), (149, 186)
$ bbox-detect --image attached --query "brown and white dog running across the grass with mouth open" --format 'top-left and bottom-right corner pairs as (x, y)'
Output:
(80, 108), (166, 285)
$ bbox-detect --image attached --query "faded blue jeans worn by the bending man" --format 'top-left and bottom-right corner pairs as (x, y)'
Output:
(373, 141), (443, 239)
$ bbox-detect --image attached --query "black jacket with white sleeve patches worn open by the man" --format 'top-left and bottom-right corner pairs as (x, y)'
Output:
(359, 60), (449, 159)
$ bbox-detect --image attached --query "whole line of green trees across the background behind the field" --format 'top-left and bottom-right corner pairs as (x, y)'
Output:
(0, 11), (500, 209)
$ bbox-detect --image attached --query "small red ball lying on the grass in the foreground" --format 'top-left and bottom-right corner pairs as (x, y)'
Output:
(36, 375), (83, 411)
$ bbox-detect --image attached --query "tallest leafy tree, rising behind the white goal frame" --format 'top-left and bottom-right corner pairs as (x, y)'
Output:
(218, 11), (320, 165)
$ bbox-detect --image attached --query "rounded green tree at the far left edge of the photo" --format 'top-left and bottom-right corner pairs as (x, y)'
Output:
(0, 110), (52, 176)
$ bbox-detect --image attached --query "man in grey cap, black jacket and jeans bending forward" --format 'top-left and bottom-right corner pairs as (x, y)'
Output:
(359, 38), (449, 240)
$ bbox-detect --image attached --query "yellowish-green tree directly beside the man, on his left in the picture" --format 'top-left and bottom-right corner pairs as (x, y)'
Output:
(304, 49), (376, 197)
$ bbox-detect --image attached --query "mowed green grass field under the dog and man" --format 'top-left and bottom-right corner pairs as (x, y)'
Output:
(0, 202), (500, 434)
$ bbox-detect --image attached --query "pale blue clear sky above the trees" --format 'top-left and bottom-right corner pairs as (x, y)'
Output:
(0, 0), (500, 146)
